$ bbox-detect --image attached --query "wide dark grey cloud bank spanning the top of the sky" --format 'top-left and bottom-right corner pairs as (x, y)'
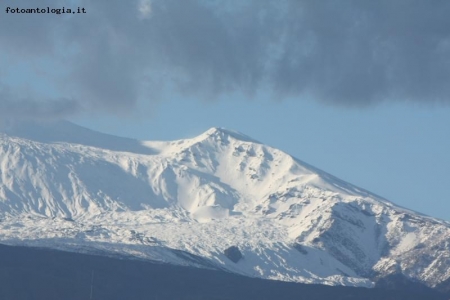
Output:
(0, 0), (450, 119)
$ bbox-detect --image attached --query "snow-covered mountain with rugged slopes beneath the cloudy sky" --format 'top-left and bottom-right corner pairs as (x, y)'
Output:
(0, 121), (450, 287)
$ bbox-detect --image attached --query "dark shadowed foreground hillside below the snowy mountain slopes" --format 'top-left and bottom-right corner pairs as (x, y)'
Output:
(0, 245), (446, 300)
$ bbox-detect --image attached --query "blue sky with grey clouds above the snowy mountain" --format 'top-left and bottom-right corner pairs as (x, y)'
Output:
(0, 0), (450, 220)
